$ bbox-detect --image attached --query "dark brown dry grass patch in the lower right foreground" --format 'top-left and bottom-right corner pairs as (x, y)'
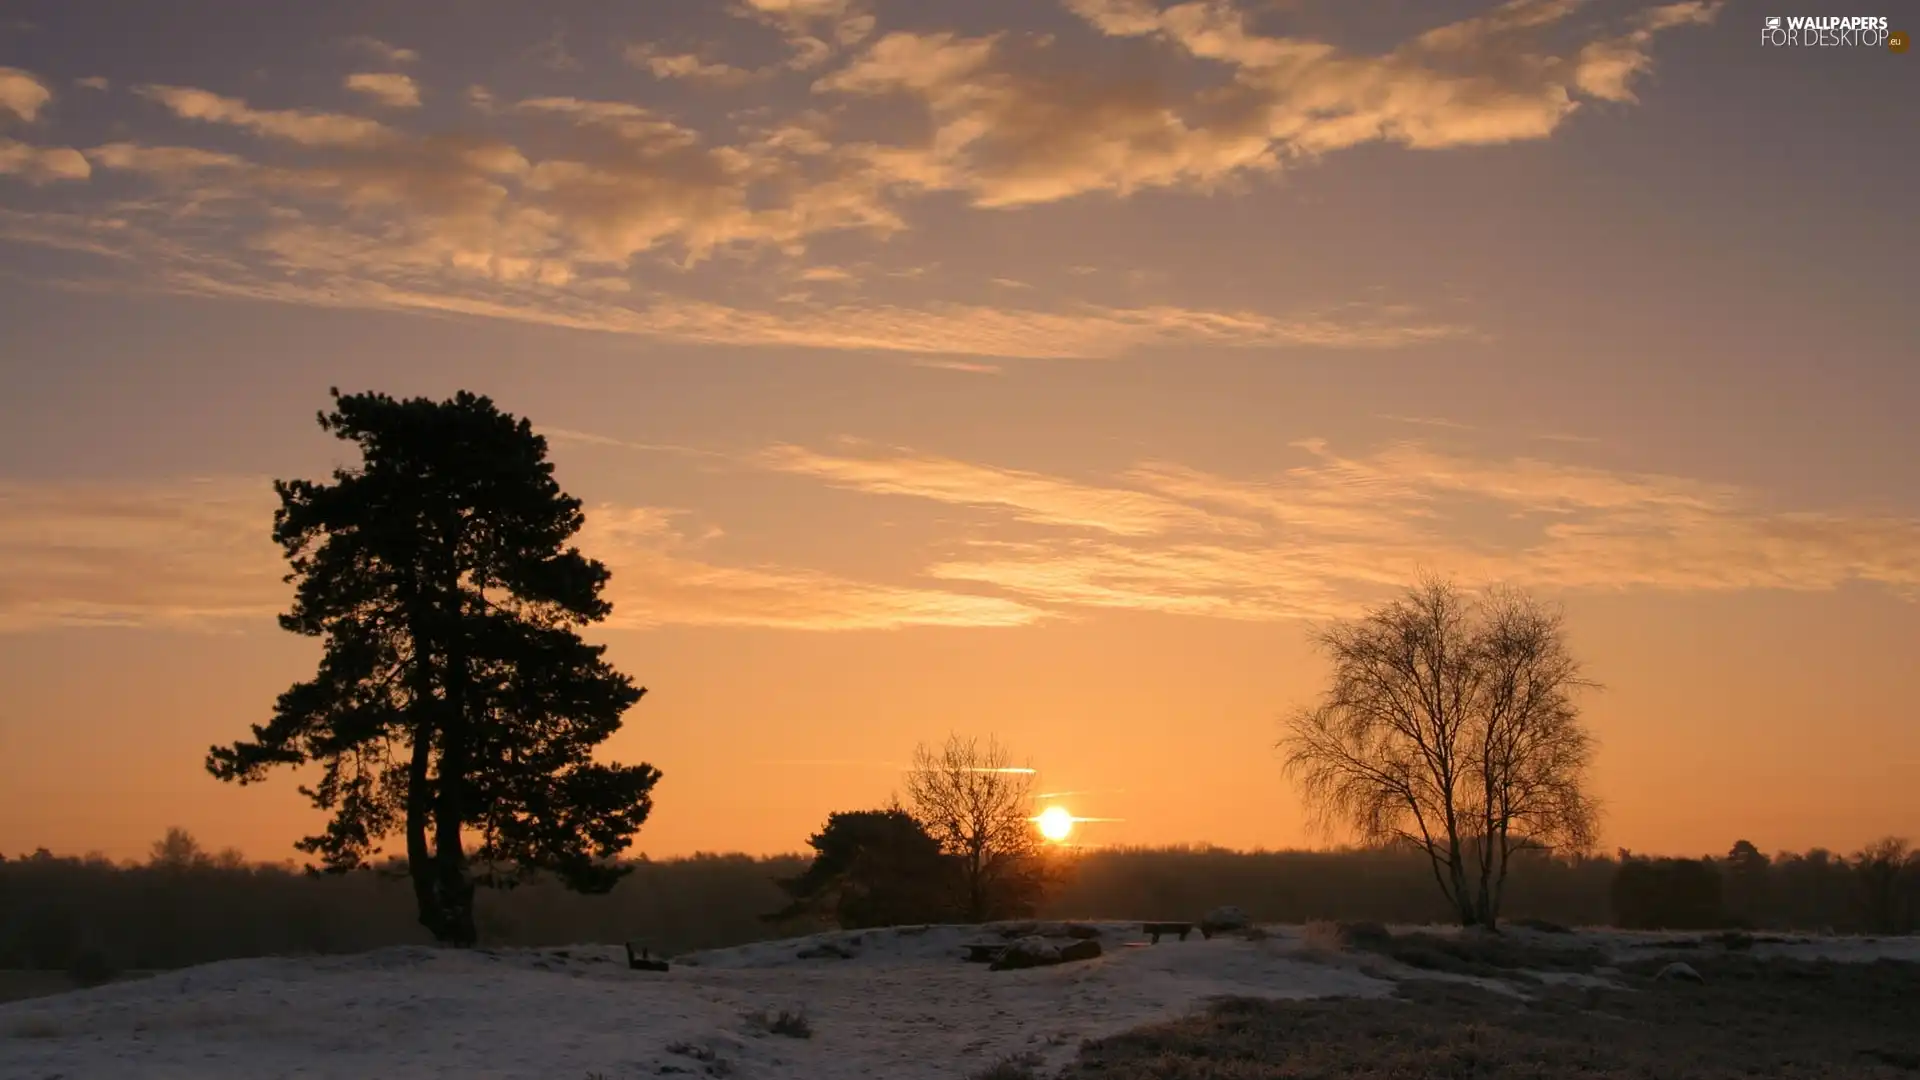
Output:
(1060, 955), (1920, 1080)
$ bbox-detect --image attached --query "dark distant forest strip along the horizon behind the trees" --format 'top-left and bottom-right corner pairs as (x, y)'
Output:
(0, 830), (1920, 970)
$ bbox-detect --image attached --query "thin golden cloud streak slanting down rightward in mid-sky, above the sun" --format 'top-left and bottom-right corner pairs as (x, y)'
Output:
(756, 446), (1258, 536)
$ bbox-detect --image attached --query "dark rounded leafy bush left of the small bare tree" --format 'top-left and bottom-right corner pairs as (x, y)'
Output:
(768, 805), (952, 930)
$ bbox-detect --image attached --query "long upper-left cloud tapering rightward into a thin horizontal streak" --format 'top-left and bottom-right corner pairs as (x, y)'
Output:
(0, 200), (1471, 359)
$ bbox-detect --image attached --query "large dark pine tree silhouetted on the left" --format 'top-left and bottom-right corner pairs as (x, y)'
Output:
(207, 390), (660, 945)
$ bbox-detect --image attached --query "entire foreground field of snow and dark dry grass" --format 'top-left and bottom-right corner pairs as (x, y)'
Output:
(0, 922), (1920, 1080)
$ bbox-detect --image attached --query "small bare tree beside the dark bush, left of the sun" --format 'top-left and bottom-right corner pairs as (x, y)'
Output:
(906, 736), (1043, 922)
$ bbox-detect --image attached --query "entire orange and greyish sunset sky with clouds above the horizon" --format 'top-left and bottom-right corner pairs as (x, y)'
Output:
(0, 0), (1920, 859)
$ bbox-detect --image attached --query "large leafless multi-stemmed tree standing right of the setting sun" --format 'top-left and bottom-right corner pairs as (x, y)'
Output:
(1281, 578), (1599, 928)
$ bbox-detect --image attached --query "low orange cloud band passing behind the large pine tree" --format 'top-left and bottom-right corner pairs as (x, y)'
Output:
(0, 477), (1044, 632)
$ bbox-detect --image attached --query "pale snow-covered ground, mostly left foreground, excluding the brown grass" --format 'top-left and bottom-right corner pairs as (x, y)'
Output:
(0, 922), (1920, 1080)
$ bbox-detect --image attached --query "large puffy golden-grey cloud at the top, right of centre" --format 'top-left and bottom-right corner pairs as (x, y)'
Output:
(814, 0), (1716, 206)
